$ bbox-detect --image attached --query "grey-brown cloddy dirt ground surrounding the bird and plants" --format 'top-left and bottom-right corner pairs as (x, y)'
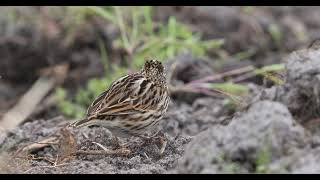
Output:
(0, 7), (320, 174)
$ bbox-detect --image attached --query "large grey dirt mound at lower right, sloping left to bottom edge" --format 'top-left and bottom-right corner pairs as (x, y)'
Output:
(177, 101), (308, 173)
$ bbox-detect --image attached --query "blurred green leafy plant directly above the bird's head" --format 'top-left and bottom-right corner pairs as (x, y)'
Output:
(74, 6), (224, 68)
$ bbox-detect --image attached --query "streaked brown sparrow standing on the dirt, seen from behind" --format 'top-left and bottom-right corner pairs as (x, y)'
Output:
(71, 60), (169, 154)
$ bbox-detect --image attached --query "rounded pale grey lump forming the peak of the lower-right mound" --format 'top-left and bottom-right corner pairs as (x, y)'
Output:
(224, 101), (305, 161)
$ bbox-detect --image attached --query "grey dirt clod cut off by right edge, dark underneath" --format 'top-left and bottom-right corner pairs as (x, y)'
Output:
(260, 48), (320, 125)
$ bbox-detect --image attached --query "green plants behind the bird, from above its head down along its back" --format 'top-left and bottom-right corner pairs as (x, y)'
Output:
(56, 6), (223, 118)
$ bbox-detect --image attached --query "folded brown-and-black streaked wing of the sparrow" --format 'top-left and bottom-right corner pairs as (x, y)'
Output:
(88, 74), (157, 118)
